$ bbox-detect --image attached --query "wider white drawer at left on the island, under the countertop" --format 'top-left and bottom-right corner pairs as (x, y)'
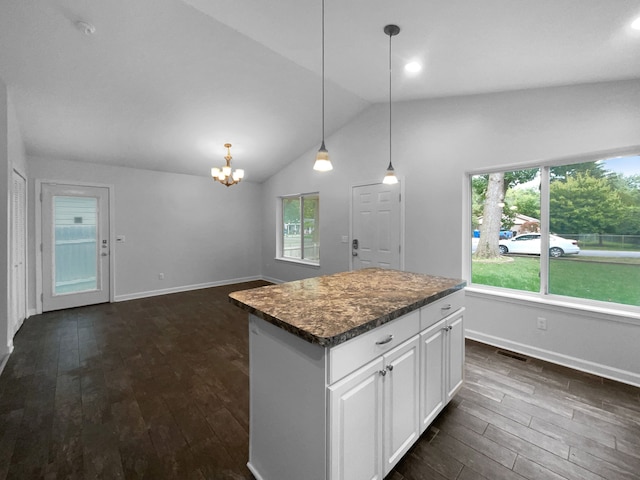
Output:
(329, 310), (420, 384)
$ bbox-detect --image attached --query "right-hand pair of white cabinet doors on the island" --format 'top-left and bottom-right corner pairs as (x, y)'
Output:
(420, 308), (464, 433)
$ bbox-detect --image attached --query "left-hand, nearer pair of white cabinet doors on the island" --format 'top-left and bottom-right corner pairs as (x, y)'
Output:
(329, 335), (420, 480)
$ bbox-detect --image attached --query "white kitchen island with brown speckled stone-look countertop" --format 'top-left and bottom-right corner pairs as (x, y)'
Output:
(229, 268), (465, 480)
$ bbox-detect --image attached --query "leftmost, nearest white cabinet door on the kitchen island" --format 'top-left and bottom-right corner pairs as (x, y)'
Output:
(329, 357), (386, 480)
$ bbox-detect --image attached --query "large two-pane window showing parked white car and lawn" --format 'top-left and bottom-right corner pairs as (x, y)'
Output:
(471, 156), (640, 306)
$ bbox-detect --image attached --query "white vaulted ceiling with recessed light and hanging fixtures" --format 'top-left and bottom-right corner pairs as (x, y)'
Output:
(0, 0), (640, 182)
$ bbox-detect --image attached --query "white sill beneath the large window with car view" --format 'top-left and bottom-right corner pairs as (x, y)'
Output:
(465, 285), (640, 325)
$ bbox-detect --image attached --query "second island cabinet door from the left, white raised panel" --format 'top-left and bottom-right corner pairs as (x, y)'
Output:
(383, 335), (420, 475)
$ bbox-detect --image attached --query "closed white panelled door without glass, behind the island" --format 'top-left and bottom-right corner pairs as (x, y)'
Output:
(351, 183), (401, 270)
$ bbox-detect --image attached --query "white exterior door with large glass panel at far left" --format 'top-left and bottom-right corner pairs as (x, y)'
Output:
(42, 184), (110, 311)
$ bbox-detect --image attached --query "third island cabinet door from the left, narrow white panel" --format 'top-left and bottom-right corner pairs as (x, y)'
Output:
(420, 320), (447, 433)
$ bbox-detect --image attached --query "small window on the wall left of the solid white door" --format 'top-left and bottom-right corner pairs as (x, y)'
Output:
(278, 193), (320, 265)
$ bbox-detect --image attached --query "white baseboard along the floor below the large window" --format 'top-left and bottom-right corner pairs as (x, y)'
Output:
(465, 330), (640, 387)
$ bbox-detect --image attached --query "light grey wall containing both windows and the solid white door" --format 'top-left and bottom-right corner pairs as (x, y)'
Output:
(262, 80), (640, 385)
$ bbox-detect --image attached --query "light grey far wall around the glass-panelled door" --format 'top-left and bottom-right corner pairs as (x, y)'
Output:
(27, 157), (261, 309)
